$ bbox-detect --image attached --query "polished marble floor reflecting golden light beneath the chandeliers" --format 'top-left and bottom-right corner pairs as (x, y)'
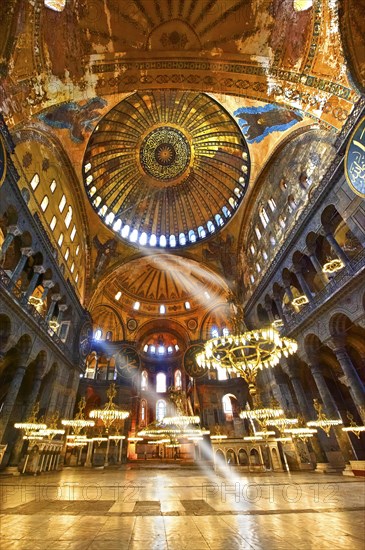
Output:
(0, 464), (365, 550)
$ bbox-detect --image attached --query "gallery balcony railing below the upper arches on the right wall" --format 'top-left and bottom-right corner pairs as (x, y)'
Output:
(282, 249), (365, 333)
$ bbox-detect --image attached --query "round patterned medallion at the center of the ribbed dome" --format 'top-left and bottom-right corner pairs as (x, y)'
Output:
(139, 126), (191, 181)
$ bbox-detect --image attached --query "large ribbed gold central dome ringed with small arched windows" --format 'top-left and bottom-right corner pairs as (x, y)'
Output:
(84, 91), (250, 248)
